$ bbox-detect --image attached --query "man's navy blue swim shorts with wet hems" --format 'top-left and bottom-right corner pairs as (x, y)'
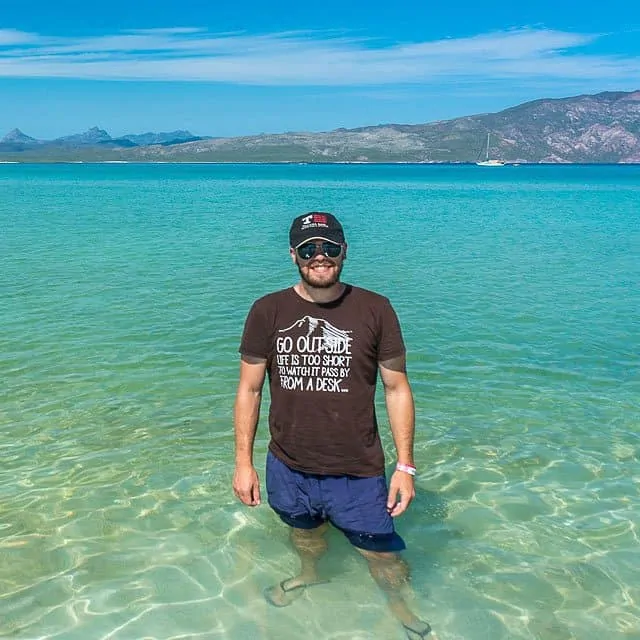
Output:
(267, 451), (405, 551)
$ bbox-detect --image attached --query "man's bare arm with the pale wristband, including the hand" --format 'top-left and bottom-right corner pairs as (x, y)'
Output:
(380, 355), (415, 517)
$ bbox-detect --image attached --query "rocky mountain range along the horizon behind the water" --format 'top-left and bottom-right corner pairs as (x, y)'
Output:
(0, 90), (640, 163)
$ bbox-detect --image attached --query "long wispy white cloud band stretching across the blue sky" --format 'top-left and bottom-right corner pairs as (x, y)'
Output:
(0, 28), (640, 86)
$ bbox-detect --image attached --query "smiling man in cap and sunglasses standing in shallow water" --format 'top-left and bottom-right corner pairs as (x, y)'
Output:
(233, 212), (432, 640)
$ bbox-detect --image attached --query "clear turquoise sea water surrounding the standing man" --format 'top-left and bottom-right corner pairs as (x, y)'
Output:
(0, 165), (640, 640)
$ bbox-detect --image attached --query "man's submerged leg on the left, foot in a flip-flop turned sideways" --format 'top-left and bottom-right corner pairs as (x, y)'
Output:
(265, 523), (328, 607)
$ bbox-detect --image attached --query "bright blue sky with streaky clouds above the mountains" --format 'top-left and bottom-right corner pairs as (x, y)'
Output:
(0, 0), (640, 138)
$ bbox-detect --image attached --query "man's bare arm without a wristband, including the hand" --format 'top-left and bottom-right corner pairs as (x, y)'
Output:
(233, 356), (267, 506)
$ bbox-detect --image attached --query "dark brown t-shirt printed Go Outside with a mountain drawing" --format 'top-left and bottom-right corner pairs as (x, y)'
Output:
(240, 285), (405, 477)
